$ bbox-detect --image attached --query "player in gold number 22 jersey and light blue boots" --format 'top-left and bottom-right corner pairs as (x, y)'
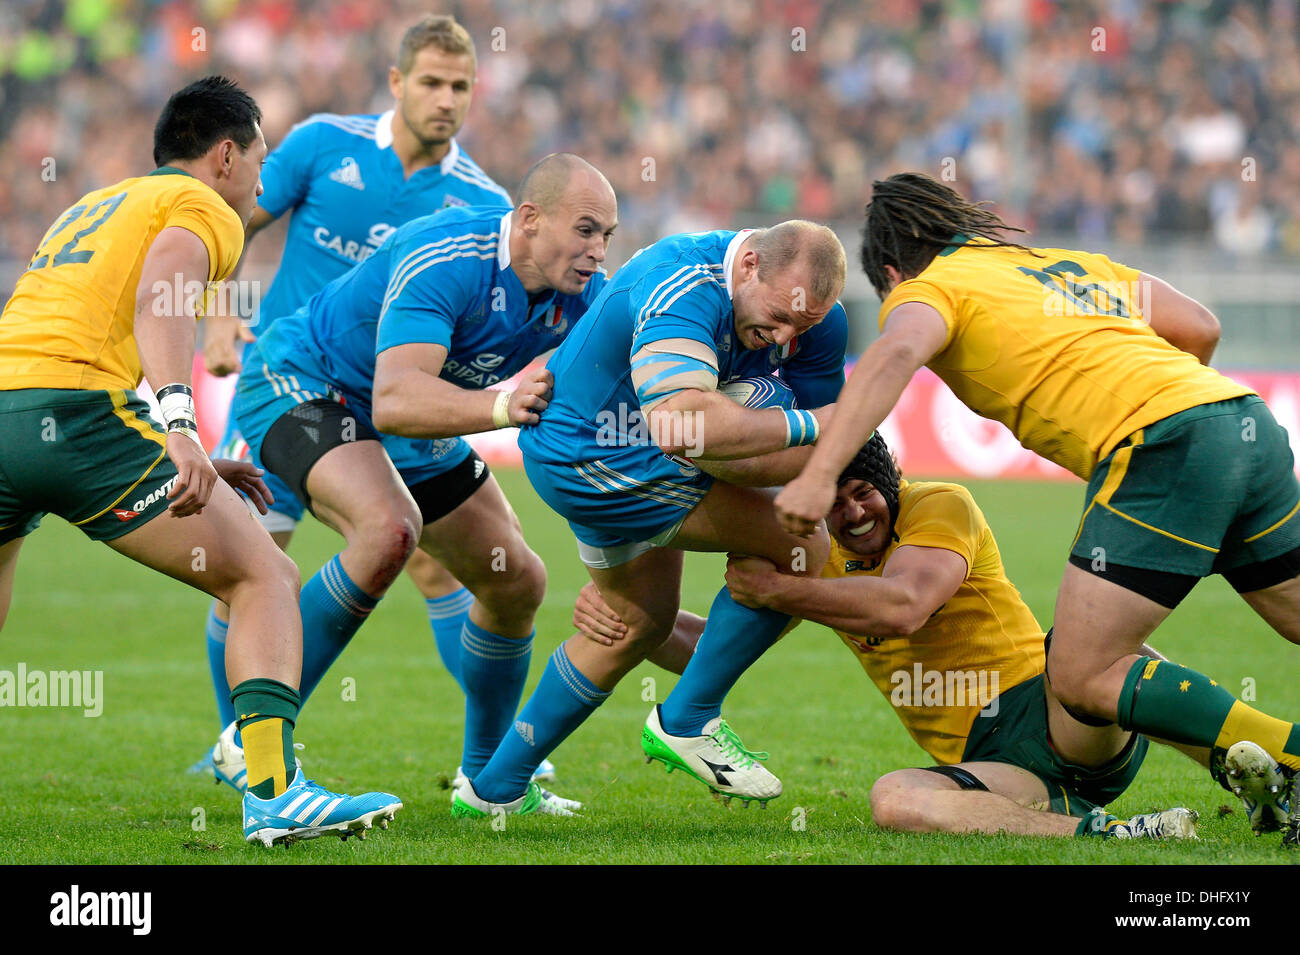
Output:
(0, 77), (402, 846)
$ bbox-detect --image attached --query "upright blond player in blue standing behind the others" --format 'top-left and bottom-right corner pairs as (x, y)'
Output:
(196, 16), (511, 764)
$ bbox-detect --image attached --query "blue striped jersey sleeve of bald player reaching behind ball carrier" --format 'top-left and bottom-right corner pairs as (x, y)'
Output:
(374, 242), (480, 355)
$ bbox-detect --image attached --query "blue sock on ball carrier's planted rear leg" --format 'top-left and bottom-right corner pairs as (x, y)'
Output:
(471, 644), (610, 803)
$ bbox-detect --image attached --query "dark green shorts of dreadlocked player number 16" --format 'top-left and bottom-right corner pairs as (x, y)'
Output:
(1070, 395), (1300, 577)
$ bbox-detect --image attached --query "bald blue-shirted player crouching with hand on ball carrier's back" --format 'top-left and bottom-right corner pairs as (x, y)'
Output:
(217, 155), (618, 812)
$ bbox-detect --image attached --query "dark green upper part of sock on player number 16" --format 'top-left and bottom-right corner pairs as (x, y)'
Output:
(1117, 660), (1236, 747)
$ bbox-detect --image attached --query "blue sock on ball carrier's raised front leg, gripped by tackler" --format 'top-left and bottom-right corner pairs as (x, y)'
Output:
(659, 587), (790, 737)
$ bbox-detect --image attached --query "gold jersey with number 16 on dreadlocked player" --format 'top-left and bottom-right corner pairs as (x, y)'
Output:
(880, 236), (1255, 481)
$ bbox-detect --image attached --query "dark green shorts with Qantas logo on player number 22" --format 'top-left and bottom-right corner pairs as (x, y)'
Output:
(0, 388), (176, 544)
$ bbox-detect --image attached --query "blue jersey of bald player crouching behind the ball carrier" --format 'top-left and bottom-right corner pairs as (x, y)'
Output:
(257, 207), (606, 409)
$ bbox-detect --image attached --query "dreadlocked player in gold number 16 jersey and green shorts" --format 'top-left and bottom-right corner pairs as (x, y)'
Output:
(776, 174), (1300, 846)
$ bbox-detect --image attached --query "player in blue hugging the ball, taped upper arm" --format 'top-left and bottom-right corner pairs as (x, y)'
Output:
(452, 221), (848, 816)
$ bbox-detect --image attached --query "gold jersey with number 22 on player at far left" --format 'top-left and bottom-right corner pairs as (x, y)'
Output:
(0, 166), (244, 391)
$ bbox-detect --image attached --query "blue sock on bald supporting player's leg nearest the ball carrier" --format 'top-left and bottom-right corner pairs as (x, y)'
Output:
(460, 617), (533, 777)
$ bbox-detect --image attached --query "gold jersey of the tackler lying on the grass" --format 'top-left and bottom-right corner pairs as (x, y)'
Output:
(822, 481), (1045, 764)
